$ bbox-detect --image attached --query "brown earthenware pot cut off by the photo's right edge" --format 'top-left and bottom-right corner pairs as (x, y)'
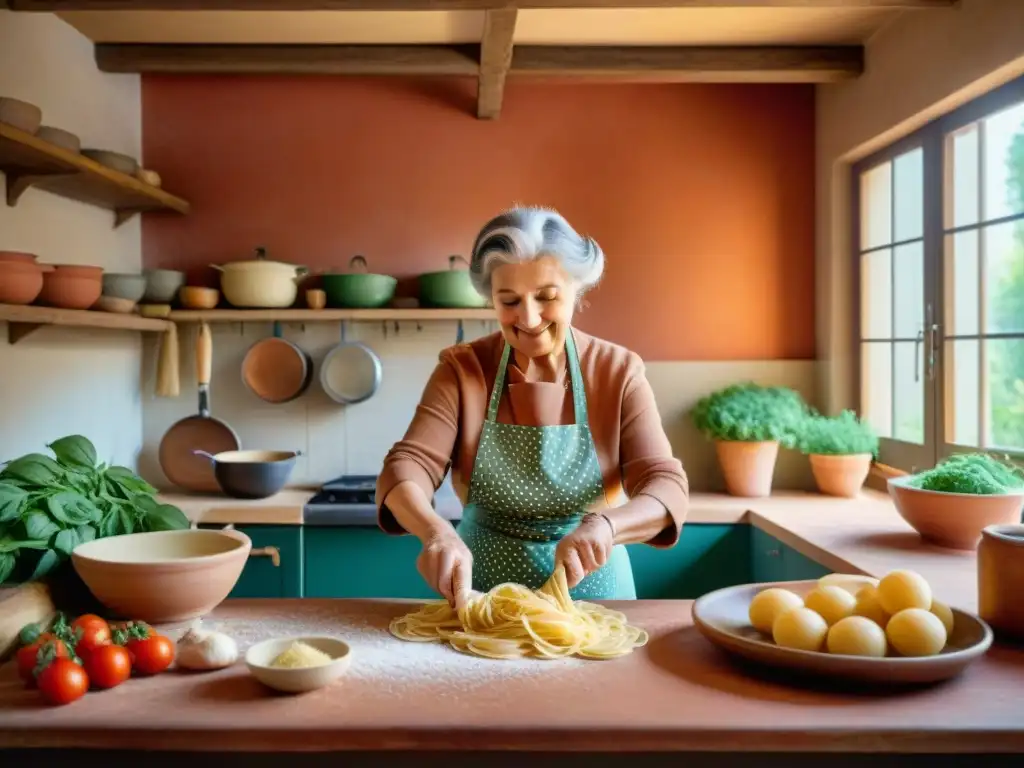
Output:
(978, 523), (1024, 640)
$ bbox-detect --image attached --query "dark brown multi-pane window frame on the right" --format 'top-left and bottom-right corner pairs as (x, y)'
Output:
(850, 76), (1024, 472)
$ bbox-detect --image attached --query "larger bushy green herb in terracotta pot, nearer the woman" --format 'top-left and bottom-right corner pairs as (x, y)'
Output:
(690, 382), (807, 497)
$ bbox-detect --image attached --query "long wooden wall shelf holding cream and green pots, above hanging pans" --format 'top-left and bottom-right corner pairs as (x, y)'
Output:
(170, 308), (496, 323)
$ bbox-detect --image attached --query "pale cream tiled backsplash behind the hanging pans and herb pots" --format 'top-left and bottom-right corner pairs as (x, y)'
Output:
(138, 321), (816, 489)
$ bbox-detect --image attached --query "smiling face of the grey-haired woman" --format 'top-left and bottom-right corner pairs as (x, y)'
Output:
(490, 256), (577, 357)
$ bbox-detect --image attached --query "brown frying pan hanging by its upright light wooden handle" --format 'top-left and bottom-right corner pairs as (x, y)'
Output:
(160, 322), (242, 494)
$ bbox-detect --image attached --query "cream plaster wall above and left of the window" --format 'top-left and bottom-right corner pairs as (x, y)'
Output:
(816, 0), (1024, 411)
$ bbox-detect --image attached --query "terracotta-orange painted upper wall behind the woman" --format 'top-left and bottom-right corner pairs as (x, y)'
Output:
(142, 77), (815, 360)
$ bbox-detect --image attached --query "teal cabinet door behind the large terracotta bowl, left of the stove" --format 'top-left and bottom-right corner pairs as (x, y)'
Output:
(201, 525), (303, 598)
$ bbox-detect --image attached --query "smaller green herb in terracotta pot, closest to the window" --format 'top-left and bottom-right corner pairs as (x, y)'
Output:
(797, 411), (879, 498)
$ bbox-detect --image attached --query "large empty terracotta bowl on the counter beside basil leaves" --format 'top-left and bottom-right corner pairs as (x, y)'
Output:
(72, 529), (252, 624)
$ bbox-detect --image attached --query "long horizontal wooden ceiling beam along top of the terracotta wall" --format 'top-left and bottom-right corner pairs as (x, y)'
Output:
(95, 41), (863, 83)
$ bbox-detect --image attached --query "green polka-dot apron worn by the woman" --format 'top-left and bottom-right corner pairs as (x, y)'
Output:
(459, 332), (636, 600)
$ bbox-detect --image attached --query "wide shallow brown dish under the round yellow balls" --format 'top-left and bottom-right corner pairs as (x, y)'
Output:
(692, 581), (992, 685)
